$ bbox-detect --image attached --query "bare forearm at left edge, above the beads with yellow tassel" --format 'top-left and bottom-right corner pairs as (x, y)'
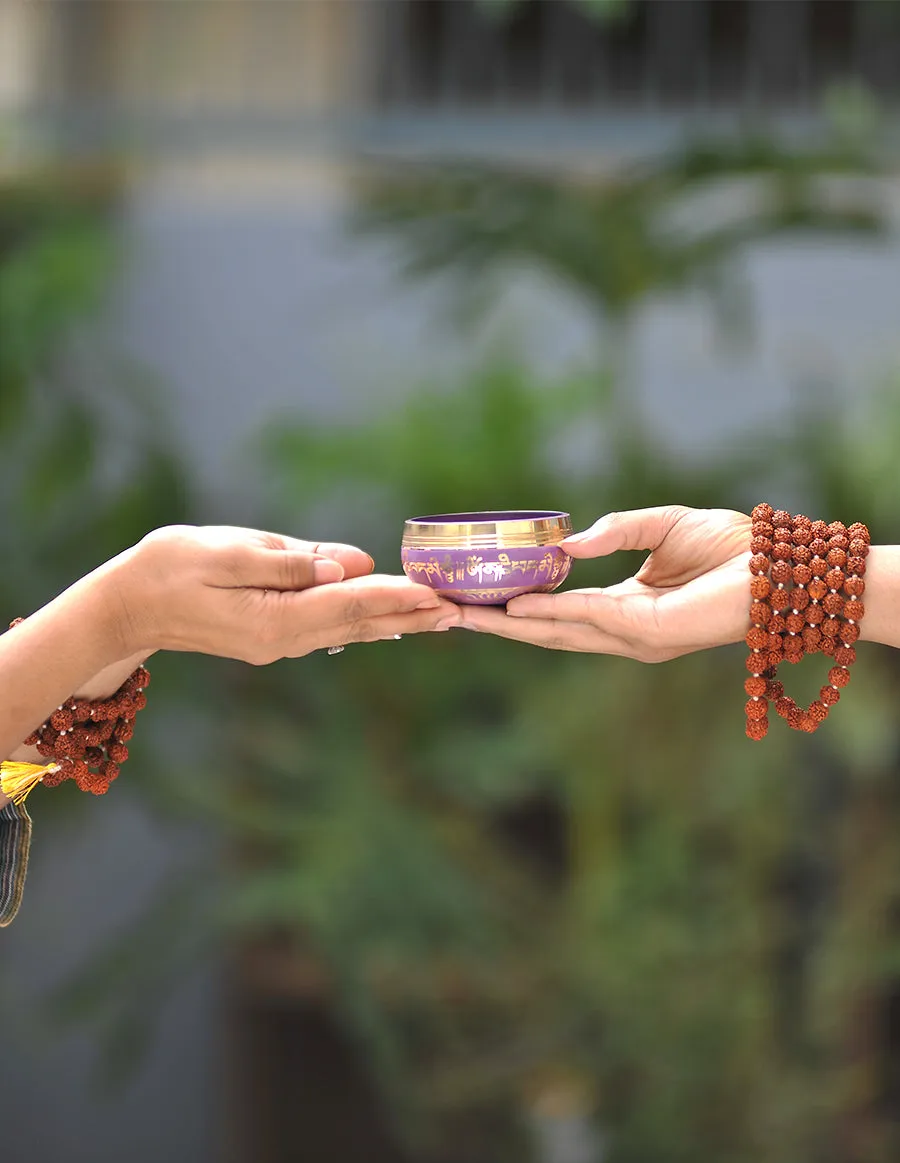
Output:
(0, 548), (147, 807)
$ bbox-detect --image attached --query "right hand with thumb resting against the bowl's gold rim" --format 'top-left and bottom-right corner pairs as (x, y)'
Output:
(460, 505), (751, 662)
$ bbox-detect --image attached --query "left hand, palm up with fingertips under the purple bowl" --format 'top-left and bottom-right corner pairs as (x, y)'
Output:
(112, 526), (459, 665)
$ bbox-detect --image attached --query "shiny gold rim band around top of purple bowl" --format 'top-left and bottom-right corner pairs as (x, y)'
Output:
(402, 509), (572, 549)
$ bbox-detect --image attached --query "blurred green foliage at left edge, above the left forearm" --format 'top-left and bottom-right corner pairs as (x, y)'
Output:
(0, 169), (187, 612)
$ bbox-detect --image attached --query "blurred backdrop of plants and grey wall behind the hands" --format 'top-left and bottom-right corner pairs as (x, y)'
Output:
(0, 0), (900, 1163)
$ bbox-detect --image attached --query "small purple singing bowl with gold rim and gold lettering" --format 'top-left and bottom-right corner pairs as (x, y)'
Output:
(400, 509), (572, 606)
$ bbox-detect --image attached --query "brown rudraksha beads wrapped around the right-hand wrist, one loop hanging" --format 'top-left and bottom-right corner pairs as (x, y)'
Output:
(744, 504), (870, 740)
